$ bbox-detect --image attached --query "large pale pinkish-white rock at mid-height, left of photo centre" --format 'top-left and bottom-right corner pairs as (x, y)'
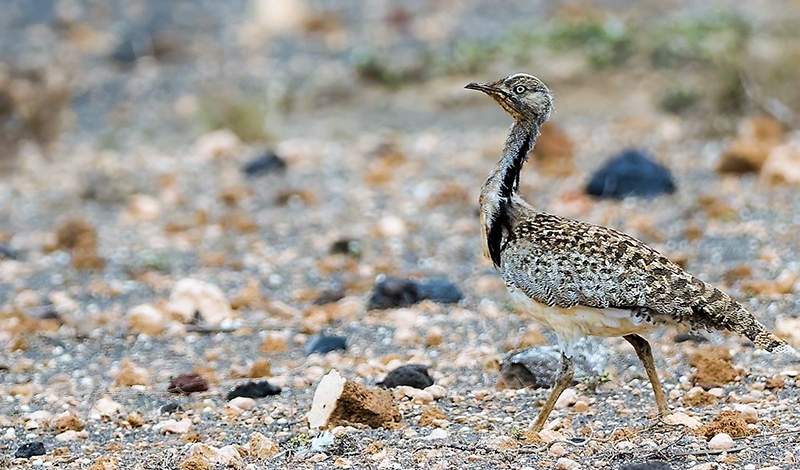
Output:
(167, 278), (233, 325)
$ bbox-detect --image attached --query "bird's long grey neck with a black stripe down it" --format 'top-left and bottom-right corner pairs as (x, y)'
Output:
(480, 121), (540, 267)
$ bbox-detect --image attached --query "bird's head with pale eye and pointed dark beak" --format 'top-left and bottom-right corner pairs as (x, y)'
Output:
(465, 73), (553, 124)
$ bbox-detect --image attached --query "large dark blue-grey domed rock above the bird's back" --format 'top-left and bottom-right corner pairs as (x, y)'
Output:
(586, 150), (675, 199)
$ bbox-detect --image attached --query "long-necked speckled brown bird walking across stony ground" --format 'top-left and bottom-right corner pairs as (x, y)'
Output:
(465, 73), (796, 431)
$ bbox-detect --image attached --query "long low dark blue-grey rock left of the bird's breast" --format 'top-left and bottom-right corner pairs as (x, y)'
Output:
(367, 276), (463, 310)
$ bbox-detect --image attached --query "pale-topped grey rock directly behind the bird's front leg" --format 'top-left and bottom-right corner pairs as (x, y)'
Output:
(500, 338), (608, 388)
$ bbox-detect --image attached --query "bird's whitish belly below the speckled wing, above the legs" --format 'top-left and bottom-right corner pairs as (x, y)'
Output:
(511, 290), (656, 343)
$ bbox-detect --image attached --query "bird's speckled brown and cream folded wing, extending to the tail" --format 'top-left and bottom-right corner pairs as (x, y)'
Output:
(501, 213), (782, 350)
